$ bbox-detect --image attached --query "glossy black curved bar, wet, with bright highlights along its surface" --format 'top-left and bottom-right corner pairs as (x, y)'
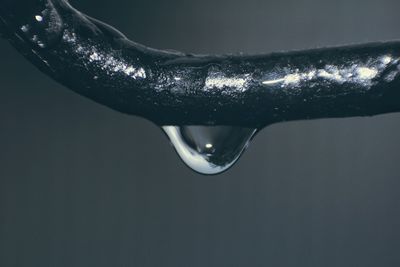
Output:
(0, 0), (400, 128)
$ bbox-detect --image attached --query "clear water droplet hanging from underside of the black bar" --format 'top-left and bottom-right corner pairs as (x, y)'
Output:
(162, 126), (257, 175)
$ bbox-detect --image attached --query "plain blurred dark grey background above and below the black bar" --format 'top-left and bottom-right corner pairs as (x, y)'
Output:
(0, 0), (400, 267)
